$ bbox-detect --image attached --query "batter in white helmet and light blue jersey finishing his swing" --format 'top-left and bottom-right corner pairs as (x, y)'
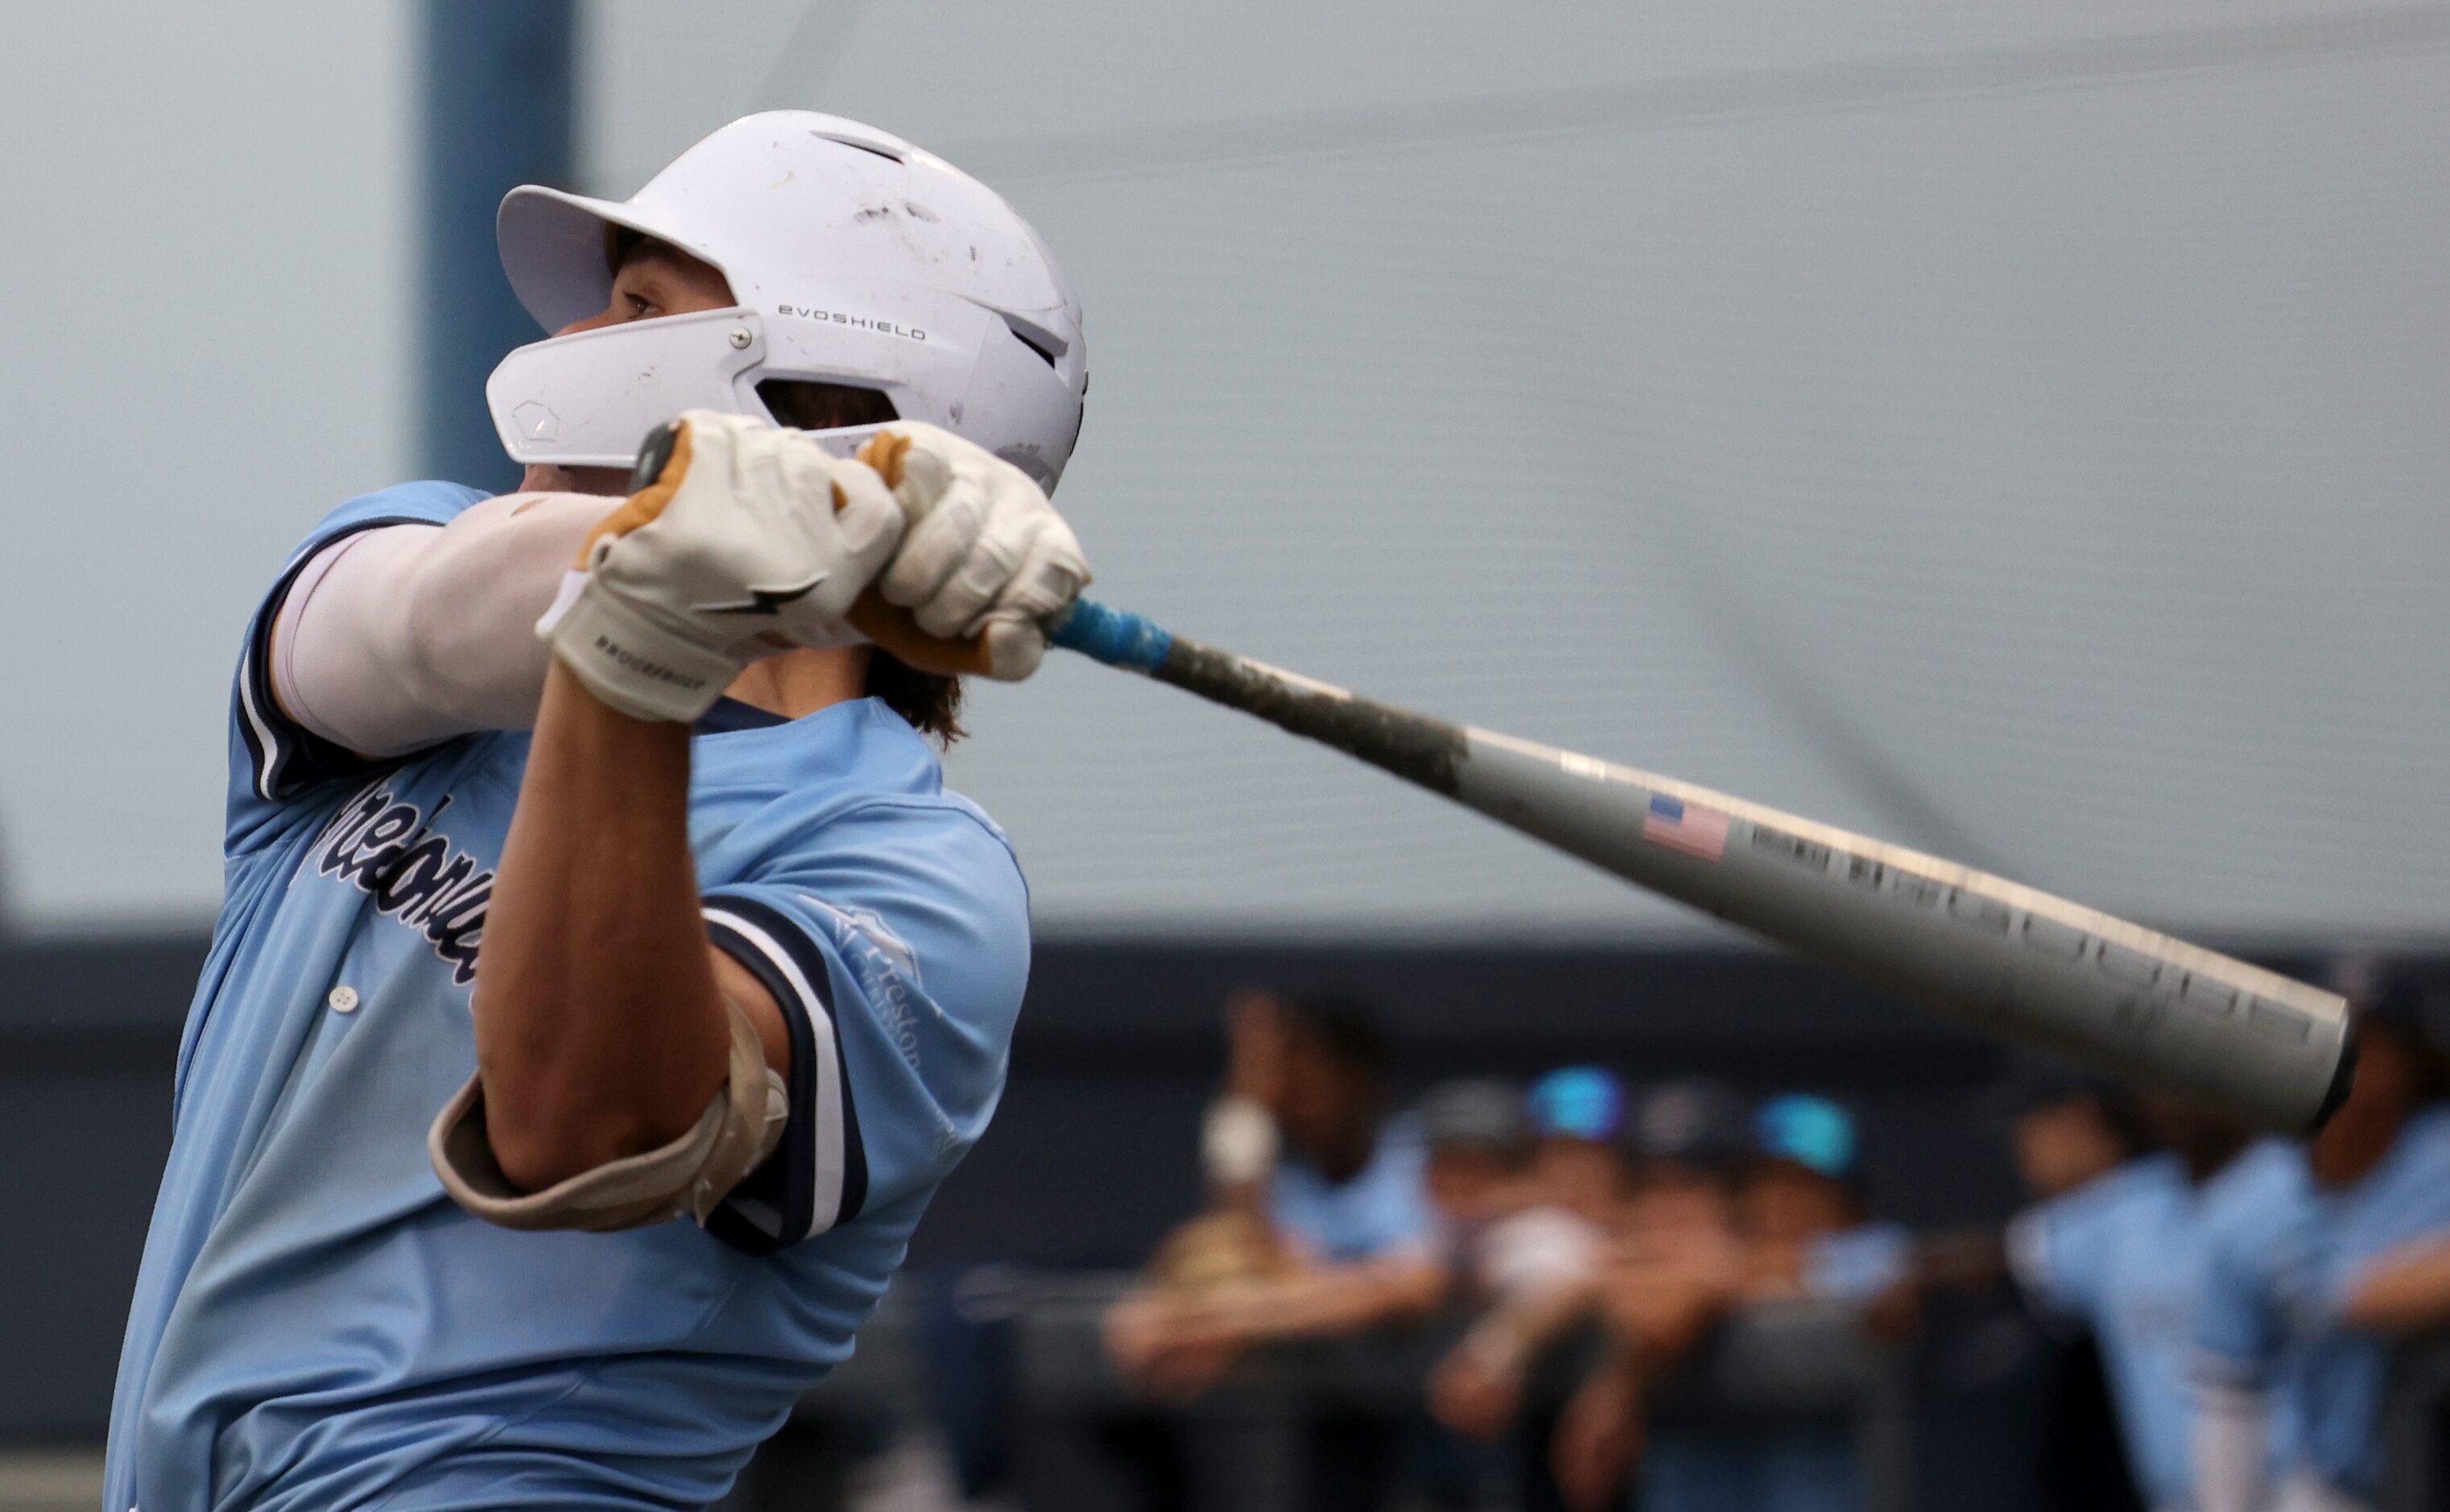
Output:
(108, 113), (1088, 1512)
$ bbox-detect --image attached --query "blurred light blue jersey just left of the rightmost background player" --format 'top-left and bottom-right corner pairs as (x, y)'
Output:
(2009, 1142), (2293, 1507)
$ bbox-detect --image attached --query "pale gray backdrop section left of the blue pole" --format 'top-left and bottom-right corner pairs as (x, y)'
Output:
(0, 0), (419, 927)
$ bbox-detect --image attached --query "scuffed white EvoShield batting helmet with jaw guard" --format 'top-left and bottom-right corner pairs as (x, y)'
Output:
(485, 110), (1088, 490)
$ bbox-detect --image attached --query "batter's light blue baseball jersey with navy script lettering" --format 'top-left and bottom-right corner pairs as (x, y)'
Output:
(108, 483), (1029, 1512)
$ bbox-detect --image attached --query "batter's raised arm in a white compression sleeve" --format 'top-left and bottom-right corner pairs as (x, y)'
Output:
(272, 493), (615, 754)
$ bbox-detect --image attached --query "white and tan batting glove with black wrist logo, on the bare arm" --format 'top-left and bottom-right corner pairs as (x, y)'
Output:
(536, 409), (902, 723)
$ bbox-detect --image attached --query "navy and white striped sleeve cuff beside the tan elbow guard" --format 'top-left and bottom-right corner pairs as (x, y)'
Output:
(703, 892), (867, 1254)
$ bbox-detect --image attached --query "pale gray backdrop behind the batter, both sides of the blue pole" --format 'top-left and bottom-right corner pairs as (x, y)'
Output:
(0, 0), (2450, 939)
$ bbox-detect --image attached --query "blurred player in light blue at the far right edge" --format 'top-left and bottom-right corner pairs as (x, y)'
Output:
(2192, 977), (2450, 1512)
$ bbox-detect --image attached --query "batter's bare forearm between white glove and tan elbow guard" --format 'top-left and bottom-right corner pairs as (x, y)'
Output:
(475, 664), (728, 1188)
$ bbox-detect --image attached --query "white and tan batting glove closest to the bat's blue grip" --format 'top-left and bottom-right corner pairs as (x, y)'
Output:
(860, 422), (1088, 681)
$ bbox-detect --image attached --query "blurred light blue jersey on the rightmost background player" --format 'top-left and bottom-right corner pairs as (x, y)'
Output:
(2196, 1108), (2450, 1495)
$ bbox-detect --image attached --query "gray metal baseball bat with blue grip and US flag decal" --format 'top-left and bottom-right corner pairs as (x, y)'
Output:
(1048, 601), (2354, 1132)
